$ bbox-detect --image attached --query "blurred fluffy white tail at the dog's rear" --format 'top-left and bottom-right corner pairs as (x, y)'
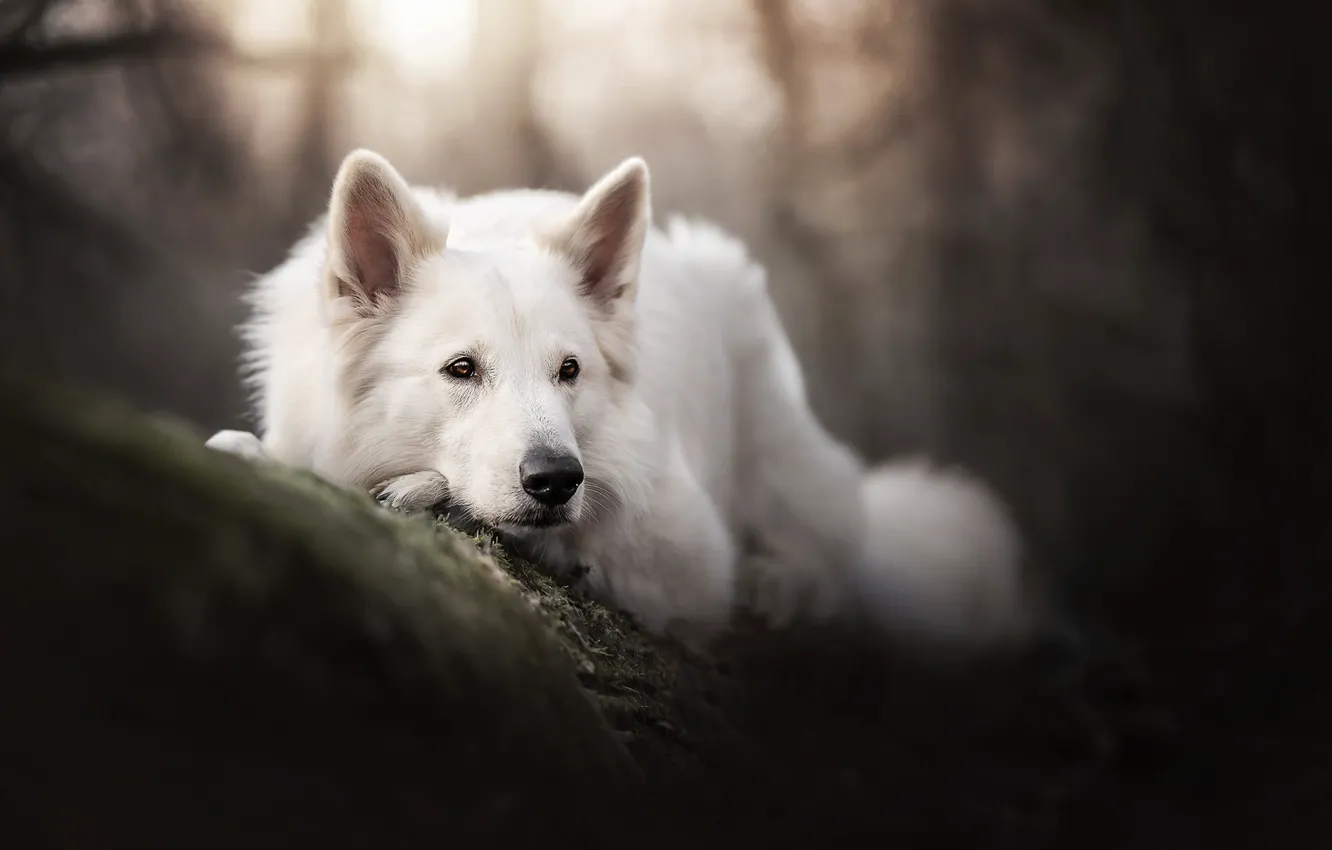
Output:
(852, 458), (1032, 646)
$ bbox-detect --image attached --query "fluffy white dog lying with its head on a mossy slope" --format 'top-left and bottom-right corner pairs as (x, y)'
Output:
(209, 151), (1028, 652)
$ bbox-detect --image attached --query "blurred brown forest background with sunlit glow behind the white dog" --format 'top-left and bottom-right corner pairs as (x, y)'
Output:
(0, 0), (1329, 703)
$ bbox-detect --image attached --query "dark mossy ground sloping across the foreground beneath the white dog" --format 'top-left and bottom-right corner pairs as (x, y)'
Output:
(0, 378), (1321, 849)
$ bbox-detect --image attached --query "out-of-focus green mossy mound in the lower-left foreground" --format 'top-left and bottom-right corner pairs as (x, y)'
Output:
(0, 382), (660, 847)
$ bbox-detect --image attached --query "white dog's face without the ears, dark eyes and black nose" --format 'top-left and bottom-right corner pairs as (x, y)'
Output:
(356, 249), (613, 525)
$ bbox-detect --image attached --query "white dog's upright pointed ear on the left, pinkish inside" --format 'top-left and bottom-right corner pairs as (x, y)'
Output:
(326, 151), (446, 316)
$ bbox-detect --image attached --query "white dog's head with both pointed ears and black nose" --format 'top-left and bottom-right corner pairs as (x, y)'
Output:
(325, 151), (650, 528)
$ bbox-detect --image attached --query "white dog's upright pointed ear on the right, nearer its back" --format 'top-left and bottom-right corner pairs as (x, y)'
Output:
(547, 157), (651, 309)
